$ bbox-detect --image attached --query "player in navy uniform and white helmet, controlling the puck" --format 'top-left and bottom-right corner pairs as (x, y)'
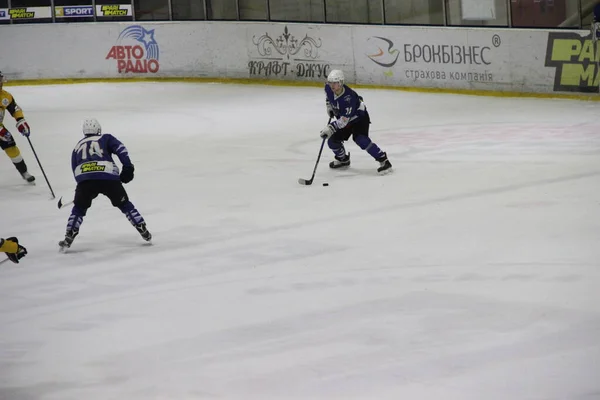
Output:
(320, 69), (392, 174)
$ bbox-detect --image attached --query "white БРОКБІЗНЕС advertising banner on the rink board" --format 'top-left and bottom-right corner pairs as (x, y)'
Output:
(354, 27), (510, 88)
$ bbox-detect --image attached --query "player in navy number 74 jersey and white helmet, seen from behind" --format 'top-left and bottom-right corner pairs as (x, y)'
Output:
(58, 118), (152, 251)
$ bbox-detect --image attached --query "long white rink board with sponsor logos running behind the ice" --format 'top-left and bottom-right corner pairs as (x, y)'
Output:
(0, 21), (598, 92)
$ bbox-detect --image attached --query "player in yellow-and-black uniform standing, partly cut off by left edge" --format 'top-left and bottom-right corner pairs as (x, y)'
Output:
(0, 71), (35, 182)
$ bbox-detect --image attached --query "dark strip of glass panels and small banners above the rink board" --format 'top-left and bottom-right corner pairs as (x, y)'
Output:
(0, 0), (600, 29)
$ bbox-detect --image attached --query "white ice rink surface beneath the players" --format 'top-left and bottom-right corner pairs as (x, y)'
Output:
(0, 83), (600, 400)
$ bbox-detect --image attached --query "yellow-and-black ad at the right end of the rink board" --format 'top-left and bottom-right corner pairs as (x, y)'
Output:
(545, 32), (599, 93)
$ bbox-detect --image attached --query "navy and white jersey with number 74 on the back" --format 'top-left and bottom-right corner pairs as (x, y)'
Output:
(71, 134), (132, 183)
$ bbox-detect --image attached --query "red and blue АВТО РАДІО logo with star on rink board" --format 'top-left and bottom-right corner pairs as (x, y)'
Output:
(106, 25), (159, 74)
